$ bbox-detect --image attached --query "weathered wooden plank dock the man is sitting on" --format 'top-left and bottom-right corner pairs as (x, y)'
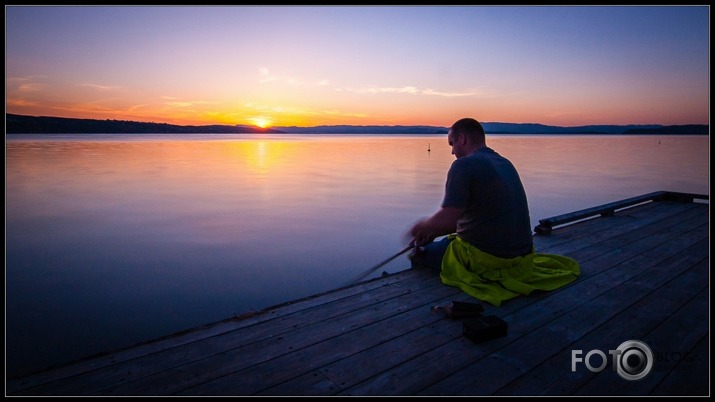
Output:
(6, 192), (710, 396)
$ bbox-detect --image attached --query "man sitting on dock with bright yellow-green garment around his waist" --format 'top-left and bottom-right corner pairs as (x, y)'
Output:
(409, 118), (580, 306)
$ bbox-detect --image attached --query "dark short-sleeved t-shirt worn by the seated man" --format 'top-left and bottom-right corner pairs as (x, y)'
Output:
(442, 147), (533, 258)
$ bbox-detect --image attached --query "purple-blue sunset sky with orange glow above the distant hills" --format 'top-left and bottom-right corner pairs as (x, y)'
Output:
(5, 5), (710, 127)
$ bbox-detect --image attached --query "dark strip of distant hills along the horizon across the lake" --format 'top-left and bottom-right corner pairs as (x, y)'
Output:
(5, 113), (710, 135)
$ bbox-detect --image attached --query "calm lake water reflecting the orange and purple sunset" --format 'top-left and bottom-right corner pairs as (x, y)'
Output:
(5, 135), (710, 375)
